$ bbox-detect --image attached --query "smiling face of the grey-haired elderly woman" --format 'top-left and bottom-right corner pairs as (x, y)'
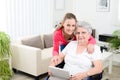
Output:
(75, 27), (90, 43)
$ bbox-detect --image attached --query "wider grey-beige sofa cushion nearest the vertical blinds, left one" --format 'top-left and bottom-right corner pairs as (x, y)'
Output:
(22, 36), (44, 49)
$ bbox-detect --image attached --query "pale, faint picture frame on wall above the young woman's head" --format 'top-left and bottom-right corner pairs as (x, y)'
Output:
(54, 0), (65, 10)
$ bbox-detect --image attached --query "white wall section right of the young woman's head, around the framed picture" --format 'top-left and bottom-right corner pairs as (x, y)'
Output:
(73, 0), (120, 38)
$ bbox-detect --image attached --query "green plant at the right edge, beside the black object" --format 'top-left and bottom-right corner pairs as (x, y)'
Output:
(109, 30), (120, 53)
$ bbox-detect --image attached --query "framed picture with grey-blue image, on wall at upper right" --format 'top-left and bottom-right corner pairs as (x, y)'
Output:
(96, 0), (110, 12)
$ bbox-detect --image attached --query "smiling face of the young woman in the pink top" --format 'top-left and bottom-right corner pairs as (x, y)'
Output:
(63, 19), (76, 35)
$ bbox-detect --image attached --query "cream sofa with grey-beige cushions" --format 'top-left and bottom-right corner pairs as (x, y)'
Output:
(11, 33), (53, 80)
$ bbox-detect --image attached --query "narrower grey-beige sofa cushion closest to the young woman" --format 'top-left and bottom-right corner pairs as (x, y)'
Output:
(43, 34), (53, 48)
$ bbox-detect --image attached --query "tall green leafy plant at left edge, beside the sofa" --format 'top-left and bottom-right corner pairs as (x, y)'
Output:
(0, 32), (13, 80)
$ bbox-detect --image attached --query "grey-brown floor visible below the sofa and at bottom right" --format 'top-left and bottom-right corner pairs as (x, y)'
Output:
(12, 66), (120, 80)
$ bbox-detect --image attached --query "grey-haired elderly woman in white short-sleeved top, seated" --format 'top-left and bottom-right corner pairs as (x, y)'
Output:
(50, 21), (102, 80)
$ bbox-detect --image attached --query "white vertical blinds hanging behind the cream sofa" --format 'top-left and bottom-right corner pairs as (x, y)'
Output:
(6, 0), (53, 40)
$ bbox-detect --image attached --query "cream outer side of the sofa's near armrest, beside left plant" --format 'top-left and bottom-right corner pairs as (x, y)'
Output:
(11, 44), (41, 75)
